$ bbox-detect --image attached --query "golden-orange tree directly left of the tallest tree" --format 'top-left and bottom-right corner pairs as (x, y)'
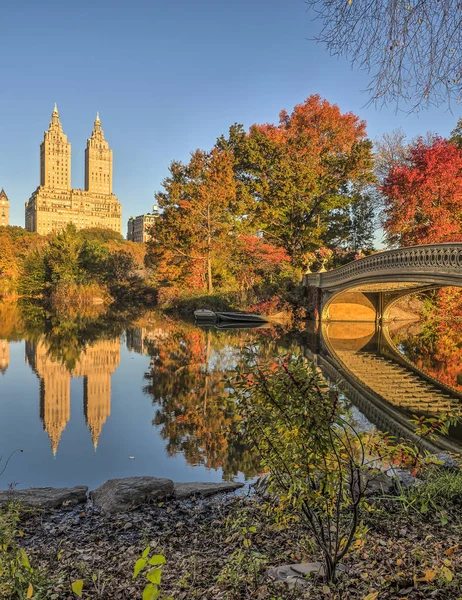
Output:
(147, 148), (238, 293)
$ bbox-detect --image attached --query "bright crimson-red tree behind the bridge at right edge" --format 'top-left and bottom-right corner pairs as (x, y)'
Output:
(381, 138), (462, 246)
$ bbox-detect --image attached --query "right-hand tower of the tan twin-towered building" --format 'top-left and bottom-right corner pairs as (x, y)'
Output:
(85, 113), (112, 194)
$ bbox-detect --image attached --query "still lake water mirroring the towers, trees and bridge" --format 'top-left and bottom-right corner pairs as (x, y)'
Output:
(0, 305), (462, 489)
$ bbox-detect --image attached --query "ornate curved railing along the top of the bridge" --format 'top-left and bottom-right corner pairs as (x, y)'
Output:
(303, 243), (462, 288)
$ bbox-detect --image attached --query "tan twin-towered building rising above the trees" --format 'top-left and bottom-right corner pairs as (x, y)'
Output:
(26, 104), (122, 234)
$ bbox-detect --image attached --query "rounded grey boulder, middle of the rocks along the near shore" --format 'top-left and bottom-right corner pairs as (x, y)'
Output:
(90, 477), (173, 513)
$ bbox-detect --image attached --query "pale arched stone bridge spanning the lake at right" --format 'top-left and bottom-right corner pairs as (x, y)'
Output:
(303, 243), (462, 322)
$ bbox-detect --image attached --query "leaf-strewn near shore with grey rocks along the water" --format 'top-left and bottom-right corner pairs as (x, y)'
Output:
(0, 464), (462, 600)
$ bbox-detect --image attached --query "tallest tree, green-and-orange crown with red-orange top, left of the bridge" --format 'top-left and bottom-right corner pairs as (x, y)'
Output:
(217, 95), (373, 265)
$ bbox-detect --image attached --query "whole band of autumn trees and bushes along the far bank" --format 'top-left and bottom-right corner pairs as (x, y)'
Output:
(0, 95), (462, 313)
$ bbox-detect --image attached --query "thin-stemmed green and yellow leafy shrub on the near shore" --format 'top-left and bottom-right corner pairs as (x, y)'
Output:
(231, 352), (456, 581)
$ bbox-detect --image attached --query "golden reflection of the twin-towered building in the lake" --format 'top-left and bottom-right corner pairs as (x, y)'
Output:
(26, 339), (120, 454)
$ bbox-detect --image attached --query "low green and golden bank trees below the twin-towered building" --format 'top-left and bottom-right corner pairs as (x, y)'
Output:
(0, 224), (155, 310)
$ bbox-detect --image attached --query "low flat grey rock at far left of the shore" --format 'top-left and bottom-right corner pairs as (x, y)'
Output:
(0, 485), (88, 508)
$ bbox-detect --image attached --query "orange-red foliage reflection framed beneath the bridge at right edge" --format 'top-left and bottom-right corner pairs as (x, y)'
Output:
(392, 288), (462, 391)
